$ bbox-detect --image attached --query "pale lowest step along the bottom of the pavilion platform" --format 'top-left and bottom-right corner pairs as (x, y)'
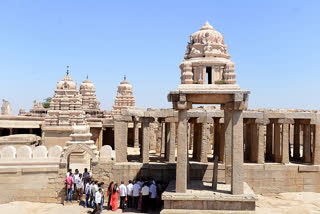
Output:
(160, 209), (255, 214)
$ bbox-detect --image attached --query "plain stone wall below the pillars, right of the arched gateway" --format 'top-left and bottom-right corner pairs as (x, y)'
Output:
(93, 162), (320, 194)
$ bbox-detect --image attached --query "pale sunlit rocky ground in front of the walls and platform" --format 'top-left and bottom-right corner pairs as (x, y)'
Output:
(0, 192), (320, 214)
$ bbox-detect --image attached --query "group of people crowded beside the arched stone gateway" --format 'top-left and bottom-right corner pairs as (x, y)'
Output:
(64, 168), (165, 213)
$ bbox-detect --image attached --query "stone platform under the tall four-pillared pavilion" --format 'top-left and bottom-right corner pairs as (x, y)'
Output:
(161, 181), (257, 214)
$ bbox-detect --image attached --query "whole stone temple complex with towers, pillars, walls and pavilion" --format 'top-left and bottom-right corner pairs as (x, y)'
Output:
(0, 22), (320, 213)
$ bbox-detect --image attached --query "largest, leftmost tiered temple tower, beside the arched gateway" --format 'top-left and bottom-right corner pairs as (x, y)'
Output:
(45, 67), (85, 126)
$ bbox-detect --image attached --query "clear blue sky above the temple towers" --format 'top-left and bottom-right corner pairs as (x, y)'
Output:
(0, 0), (320, 113)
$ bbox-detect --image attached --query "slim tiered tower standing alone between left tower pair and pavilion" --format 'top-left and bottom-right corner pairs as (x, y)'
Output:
(111, 76), (135, 115)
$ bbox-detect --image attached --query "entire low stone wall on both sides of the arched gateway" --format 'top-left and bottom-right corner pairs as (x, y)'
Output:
(0, 143), (320, 203)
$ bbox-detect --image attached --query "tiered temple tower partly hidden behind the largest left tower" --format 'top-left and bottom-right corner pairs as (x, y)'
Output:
(80, 76), (103, 117)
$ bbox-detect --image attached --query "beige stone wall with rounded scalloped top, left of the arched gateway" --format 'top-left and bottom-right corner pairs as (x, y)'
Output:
(0, 146), (66, 203)
